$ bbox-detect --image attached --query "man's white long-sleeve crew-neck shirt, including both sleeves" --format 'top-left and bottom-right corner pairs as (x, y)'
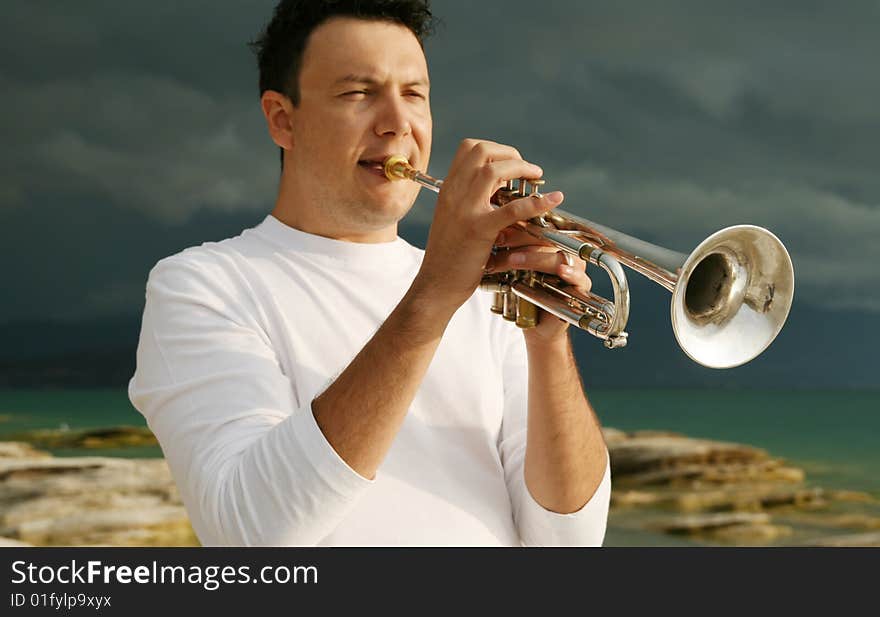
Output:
(129, 216), (611, 546)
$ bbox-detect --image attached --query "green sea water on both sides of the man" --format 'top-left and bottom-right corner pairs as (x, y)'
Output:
(0, 388), (880, 546)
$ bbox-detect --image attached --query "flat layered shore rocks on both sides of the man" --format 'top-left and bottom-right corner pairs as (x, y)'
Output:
(0, 427), (880, 546)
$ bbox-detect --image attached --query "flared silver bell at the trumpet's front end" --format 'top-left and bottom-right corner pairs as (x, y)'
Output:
(670, 225), (794, 368)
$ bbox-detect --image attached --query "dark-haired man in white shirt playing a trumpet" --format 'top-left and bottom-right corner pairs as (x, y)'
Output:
(129, 0), (610, 546)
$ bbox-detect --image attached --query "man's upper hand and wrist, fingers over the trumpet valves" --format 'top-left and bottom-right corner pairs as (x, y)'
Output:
(412, 139), (564, 317)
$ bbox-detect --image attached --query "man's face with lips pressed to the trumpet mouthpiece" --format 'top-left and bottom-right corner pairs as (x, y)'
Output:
(285, 18), (431, 236)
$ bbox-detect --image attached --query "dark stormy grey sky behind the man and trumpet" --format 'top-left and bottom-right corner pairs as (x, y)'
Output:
(0, 0), (880, 380)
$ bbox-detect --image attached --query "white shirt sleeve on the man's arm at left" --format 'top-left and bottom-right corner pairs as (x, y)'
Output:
(129, 253), (372, 546)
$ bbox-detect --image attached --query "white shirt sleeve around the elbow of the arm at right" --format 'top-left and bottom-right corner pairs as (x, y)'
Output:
(498, 324), (611, 546)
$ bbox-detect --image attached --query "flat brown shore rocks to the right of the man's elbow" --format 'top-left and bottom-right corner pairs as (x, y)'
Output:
(605, 428), (880, 546)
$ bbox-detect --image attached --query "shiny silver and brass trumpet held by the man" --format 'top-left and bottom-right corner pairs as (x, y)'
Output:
(385, 156), (794, 368)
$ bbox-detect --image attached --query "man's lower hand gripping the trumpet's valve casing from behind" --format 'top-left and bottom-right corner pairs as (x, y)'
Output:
(486, 226), (592, 346)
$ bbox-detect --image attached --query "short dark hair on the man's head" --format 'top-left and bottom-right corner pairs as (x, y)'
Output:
(249, 0), (434, 166)
